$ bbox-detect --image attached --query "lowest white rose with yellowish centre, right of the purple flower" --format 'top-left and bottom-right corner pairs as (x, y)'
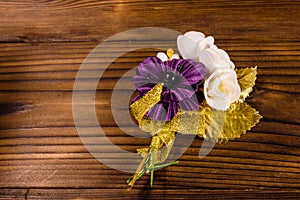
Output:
(204, 69), (241, 111)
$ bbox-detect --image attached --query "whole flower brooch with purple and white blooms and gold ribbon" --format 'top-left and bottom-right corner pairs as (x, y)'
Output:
(127, 31), (262, 188)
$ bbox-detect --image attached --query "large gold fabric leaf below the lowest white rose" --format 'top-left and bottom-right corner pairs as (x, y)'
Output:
(205, 101), (262, 142)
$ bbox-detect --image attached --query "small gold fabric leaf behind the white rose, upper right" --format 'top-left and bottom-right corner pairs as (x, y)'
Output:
(236, 67), (257, 102)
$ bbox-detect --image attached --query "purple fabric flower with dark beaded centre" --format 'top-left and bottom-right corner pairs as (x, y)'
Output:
(131, 57), (205, 121)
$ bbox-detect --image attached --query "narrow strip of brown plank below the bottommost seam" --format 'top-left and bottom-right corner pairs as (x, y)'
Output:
(23, 188), (299, 199)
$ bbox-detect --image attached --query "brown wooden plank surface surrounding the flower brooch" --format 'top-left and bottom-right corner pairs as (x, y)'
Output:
(0, 0), (300, 199)
